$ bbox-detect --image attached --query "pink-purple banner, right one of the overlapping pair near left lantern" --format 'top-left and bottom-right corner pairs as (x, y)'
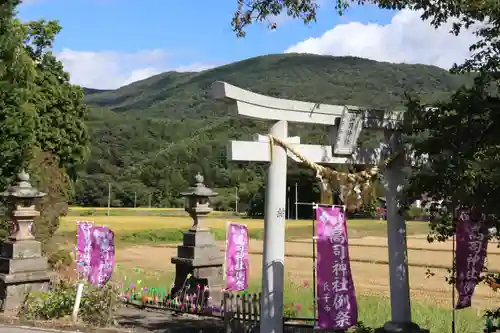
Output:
(89, 226), (115, 286)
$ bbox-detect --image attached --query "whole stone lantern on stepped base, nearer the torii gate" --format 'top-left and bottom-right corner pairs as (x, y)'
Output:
(171, 173), (224, 306)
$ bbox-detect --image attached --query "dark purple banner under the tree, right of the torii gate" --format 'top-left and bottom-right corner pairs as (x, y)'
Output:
(455, 210), (488, 309)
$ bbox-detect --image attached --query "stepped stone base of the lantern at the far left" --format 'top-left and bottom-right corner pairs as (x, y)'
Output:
(0, 240), (51, 314)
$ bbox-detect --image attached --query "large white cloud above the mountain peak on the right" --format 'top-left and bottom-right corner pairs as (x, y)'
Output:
(285, 10), (476, 69)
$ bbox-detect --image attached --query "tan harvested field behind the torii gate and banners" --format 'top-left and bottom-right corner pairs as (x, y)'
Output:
(117, 233), (500, 308)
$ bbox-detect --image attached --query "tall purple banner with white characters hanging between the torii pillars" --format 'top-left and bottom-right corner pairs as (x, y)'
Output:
(316, 207), (358, 330)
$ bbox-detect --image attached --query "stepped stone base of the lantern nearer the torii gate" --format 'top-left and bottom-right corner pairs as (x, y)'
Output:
(171, 229), (224, 306)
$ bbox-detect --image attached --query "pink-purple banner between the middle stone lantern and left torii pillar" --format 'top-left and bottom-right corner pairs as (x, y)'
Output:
(226, 223), (249, 291)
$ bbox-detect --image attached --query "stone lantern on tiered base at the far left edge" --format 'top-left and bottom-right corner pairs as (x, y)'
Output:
(0, 171), (51, 314)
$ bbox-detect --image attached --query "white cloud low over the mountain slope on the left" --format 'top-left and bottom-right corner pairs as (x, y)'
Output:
(56, 49), (214, 89)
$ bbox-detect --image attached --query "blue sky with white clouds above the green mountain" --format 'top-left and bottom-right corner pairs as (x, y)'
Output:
(19, 0), (476, 88)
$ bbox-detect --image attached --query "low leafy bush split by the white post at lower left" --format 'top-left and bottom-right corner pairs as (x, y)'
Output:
(19, 280), (121, 327)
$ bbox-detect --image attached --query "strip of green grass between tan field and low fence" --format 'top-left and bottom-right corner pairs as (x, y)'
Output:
(115, 267), (484, 333)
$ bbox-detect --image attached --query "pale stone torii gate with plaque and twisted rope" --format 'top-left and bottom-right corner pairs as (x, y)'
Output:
(212, 81), (419, 333)
